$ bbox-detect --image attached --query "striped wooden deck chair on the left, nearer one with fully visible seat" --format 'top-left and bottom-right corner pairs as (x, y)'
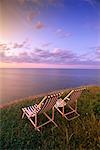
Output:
(22, 93), (61, 131)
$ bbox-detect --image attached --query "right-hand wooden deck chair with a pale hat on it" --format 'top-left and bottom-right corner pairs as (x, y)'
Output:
(55, 89), (84, 120)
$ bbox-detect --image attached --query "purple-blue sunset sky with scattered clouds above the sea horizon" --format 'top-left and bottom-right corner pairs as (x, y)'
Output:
(0, 0), (100, 69)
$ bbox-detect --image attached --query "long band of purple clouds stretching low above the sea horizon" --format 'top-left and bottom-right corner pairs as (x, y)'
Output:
(0, 41), (100, 66)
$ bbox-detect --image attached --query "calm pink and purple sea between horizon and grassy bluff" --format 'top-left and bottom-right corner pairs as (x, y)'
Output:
(0, 69), (100, 104)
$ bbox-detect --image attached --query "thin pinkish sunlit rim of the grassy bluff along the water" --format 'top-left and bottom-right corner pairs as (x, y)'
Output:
(0, 85), (98, 109)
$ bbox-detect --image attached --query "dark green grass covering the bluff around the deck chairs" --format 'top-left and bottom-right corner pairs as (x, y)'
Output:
(0, 87), (100, 150)
